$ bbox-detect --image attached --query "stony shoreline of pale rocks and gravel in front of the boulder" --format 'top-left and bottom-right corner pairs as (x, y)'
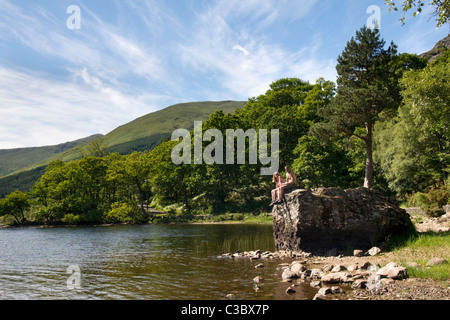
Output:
(220, 247), (450, 300)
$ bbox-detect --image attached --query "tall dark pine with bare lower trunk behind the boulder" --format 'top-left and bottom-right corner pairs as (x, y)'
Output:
(314, 26), (400, 188)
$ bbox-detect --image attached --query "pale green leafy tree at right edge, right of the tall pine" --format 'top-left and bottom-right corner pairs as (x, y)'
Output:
(375, 51), (450, 197)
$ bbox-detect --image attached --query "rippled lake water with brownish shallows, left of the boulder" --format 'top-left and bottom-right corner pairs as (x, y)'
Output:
(0, 224), (317, 300)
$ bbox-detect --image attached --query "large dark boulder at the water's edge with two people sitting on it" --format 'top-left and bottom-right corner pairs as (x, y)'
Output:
(273, 188), (411, 254)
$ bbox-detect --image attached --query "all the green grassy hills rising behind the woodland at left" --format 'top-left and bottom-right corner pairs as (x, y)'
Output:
(0, 101), (246, 198)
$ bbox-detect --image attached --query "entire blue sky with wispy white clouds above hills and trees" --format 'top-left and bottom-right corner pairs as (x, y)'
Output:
(0, 0), (449, 149)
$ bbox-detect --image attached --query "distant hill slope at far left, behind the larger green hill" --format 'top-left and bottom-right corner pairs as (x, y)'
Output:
(0, 134), (101, 178)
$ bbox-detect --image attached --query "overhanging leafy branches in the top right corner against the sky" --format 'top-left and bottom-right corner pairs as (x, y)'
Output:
(385, 0), (450, 27)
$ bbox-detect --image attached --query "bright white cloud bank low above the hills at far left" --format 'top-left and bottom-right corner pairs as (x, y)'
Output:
(0, 67), (164, 149)
